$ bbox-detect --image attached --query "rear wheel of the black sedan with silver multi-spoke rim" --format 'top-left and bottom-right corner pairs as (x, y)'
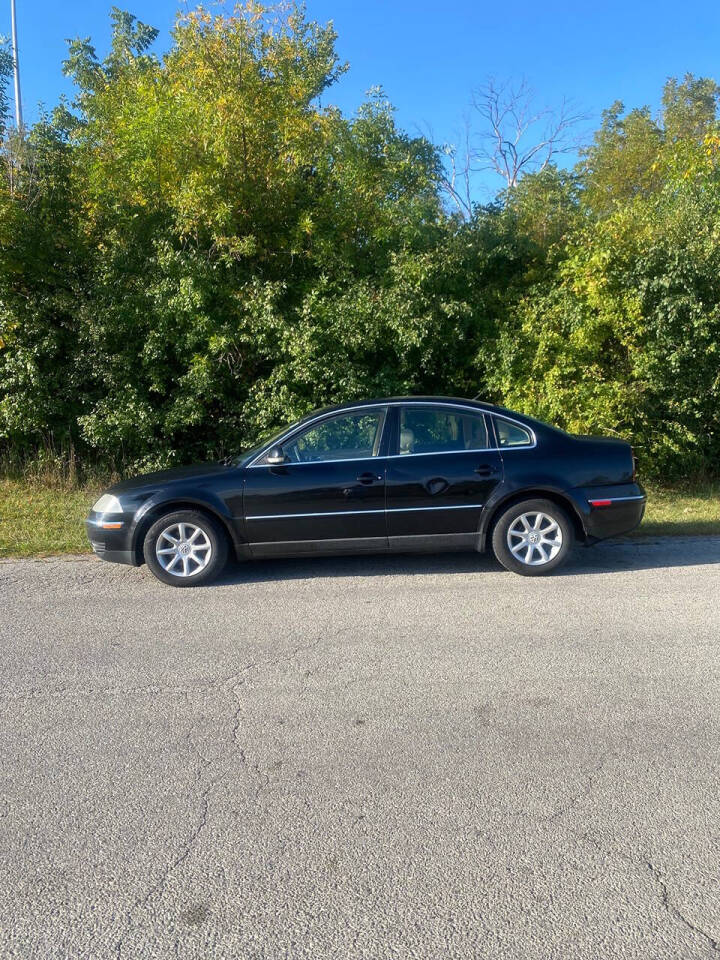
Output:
(492, 500), (575, 577)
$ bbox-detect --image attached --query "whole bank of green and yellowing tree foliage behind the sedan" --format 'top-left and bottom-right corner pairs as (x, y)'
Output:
(0, 0), (720, 476)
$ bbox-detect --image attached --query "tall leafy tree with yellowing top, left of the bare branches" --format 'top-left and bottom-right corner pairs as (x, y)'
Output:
(0, 2), (447, 469)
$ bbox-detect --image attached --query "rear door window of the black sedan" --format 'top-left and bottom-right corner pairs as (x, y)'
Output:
(399, 407), (489, 456)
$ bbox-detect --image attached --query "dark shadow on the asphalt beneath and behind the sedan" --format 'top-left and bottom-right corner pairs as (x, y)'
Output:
(214, 537), (720, 585)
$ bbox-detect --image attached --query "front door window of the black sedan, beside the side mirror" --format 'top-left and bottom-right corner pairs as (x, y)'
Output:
(276, 410), (384, 463)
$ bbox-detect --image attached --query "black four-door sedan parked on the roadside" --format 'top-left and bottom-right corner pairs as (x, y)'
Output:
(87, 397), (645, 587)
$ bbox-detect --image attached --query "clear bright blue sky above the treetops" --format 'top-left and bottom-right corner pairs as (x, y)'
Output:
(0, 0), (720, 192)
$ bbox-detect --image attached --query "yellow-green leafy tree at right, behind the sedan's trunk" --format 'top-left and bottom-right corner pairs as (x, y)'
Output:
(495, 134), (720, 478)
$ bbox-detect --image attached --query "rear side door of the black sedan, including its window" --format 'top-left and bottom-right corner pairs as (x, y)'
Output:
(387, 403), (503, 550)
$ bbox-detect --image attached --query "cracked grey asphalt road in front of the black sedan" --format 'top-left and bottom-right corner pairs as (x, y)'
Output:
(0, 539), (720, 960)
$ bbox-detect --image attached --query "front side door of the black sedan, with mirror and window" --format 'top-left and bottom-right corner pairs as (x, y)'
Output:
(243, 406), (388, 556)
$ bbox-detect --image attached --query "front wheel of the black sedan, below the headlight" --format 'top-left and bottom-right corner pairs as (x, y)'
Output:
(143, 510), (228, 587)
